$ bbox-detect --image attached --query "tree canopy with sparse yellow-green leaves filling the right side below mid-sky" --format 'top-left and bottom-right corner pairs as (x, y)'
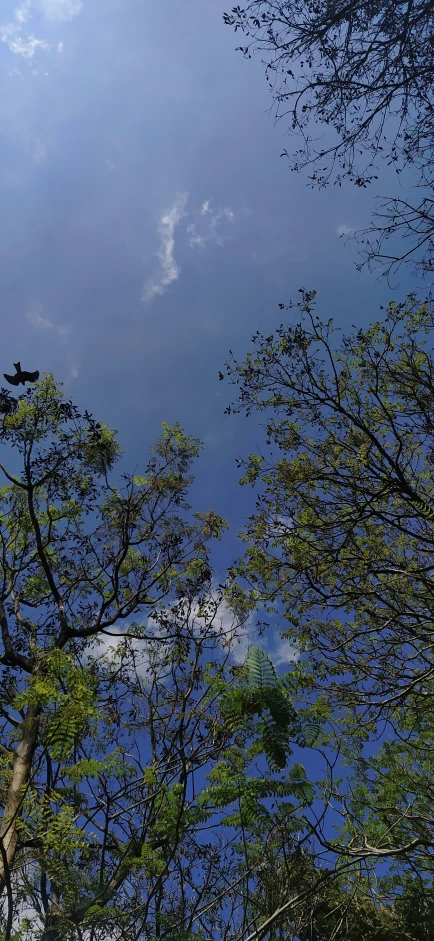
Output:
(220, 292), (434, 937)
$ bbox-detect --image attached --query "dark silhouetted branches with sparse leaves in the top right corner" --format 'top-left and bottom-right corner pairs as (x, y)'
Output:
(224, 0), (434, 274)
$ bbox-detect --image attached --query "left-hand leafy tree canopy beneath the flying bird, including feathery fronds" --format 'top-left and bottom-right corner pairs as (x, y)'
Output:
(0, 376), (322, 941)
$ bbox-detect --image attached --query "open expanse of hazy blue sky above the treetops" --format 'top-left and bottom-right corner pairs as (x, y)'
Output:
(0, 0), (420, 660)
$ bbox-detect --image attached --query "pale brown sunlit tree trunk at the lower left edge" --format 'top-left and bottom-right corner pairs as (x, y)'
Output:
(0, 706), (41, 894)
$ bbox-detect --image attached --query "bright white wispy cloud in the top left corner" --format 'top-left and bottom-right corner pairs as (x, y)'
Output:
(0, 0), (82, 59)
